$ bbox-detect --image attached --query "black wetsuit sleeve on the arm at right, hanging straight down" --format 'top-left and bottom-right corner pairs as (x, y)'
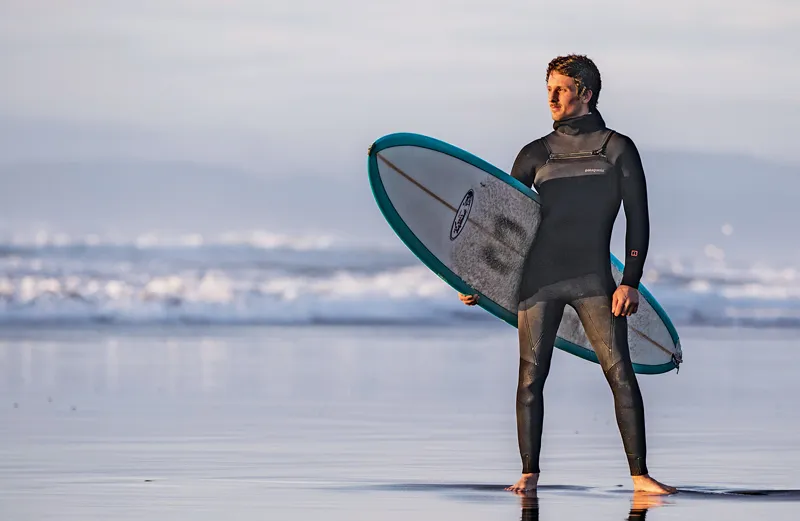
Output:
(617, 137), (650, 288)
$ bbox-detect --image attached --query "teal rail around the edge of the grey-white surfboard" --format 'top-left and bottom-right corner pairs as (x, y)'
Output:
(367, 132), (679, 374)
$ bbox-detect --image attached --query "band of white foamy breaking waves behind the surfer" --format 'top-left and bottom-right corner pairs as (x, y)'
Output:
(0, 232), (800, 327)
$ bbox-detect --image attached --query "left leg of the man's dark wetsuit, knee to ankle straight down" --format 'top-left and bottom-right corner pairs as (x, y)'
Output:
(517, 300), (566, 474)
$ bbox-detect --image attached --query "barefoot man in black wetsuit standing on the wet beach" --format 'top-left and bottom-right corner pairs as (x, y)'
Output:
(459, 55), (675, 494)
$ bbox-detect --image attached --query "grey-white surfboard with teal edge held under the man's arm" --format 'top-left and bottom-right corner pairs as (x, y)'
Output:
(367, 133), (682, 374)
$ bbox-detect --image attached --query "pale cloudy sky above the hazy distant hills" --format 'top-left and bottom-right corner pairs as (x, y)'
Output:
(0, 0), (800, 177)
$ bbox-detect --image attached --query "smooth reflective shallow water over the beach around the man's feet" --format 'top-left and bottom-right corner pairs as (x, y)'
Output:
(0, 324), (800, 521)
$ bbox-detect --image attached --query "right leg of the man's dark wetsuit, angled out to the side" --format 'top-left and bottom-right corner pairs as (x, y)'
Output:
(570, 293), (647, 476)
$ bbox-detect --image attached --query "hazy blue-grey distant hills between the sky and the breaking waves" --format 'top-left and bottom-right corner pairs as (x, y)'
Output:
(0, 151), (800, 260)
